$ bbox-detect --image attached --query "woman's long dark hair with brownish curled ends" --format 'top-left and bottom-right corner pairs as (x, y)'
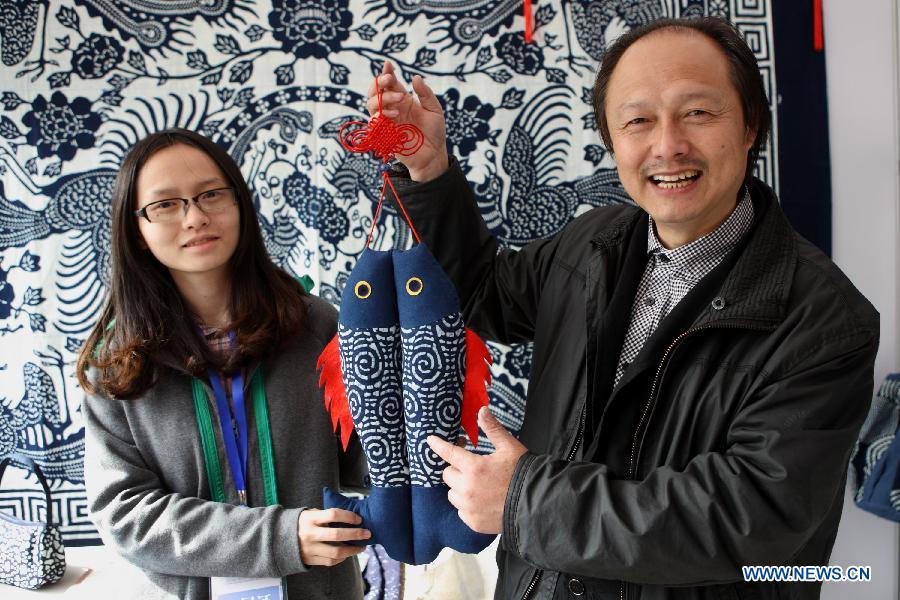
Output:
(76, 129), (306, 398)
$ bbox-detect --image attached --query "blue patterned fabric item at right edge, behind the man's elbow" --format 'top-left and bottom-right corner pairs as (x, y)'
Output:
(850, 373), (900, 521)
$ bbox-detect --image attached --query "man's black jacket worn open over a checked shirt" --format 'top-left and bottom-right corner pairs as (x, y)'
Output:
(400, 161), (879, 600)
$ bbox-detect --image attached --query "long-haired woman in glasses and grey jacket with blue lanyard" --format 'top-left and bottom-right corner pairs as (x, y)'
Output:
(77, 129), (369, 600)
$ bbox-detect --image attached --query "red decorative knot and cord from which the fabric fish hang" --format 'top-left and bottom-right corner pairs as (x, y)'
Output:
(338, 76), (425, 248)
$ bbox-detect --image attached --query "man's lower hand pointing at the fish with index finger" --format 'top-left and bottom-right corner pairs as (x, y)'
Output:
(428, 407), (528, 533)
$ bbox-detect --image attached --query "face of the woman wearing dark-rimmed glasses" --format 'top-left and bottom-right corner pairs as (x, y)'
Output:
(134, 144), (240, 281)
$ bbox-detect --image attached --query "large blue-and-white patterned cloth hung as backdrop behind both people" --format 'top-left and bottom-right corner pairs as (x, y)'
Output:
(0, 0), (788, 568)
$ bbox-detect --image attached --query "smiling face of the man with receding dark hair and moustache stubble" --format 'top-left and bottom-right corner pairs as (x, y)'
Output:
(606, 30), (756, 248)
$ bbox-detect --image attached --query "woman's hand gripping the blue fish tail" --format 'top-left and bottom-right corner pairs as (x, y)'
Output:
(297, 508), (372, 567)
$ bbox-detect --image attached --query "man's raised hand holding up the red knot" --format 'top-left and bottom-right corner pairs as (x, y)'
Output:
(366, 62), (450, 181)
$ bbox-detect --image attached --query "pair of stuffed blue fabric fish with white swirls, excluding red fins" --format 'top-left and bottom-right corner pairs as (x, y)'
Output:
(324, 244), (494, 565)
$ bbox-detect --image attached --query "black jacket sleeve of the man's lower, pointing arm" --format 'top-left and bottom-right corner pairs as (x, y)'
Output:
(503, 332), (877, 586)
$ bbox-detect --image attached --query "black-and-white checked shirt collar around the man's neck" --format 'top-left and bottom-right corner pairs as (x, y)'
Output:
(647, 188), (753, 279)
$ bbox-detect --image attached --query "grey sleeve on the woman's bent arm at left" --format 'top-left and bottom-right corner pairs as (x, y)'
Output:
(82, 386), (306, 577)
